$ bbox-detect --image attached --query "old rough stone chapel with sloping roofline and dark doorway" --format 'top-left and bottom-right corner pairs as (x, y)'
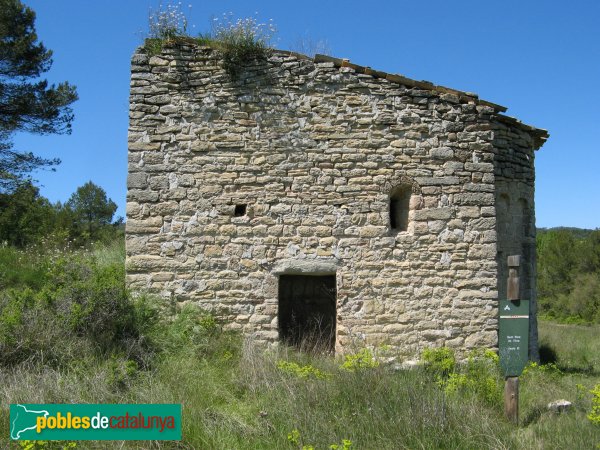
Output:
(126, 44), (548, 356)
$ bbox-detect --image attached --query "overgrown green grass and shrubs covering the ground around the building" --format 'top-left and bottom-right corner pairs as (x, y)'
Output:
(0, 246), (600, 449)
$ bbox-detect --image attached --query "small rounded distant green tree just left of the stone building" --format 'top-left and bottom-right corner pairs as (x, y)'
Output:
(66, 181), (117, 241)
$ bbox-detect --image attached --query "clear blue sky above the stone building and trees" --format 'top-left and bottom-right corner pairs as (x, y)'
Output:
(15, 0), (600, 228)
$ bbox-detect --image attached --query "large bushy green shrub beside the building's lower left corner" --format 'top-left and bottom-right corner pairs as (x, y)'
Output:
(0, 244), (157, 366)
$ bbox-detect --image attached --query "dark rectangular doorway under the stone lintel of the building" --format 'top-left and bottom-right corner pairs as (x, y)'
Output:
(279, 275), (336, 351)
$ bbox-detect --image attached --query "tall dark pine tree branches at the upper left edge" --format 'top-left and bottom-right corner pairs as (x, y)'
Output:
(0, 0), (77, 191)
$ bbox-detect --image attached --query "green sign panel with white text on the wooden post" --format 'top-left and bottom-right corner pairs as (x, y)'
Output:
(498, 300), (529, 377)
